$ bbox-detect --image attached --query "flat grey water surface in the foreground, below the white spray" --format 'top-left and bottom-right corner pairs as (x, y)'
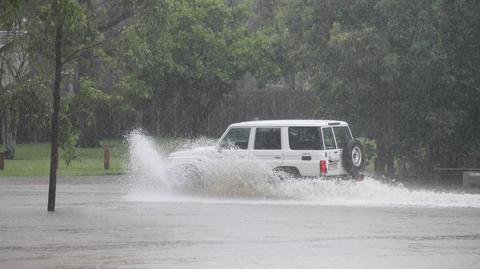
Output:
(0, 176), (480, 268)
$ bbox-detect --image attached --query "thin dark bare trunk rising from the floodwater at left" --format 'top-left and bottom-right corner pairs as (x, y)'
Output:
(48, 2), (63, 211)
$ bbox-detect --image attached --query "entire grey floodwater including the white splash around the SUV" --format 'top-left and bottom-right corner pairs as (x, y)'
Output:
(0, 134), (480, 268)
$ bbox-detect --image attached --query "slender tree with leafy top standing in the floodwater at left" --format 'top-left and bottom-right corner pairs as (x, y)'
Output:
(32, 0), (99, 211)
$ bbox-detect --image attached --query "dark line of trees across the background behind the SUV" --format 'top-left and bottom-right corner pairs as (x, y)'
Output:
(0, 0), (480, 176)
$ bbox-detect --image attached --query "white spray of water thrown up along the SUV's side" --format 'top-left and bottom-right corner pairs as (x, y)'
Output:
(123, 131), (480, 208)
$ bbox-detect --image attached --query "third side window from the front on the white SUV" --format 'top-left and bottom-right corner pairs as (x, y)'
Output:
(288, 127), (323, 150)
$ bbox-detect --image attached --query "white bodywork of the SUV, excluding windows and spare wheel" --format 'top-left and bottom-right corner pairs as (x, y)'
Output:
(169, 120), (352, 177)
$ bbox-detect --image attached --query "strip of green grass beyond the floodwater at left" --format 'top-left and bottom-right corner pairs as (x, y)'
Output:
(0, 140), (128, 177)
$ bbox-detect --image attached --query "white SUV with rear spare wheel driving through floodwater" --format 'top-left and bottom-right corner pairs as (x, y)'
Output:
(169, 120), (364, 179)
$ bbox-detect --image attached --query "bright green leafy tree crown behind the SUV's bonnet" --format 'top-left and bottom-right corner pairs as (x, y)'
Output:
(116, 0), (280, 135)
